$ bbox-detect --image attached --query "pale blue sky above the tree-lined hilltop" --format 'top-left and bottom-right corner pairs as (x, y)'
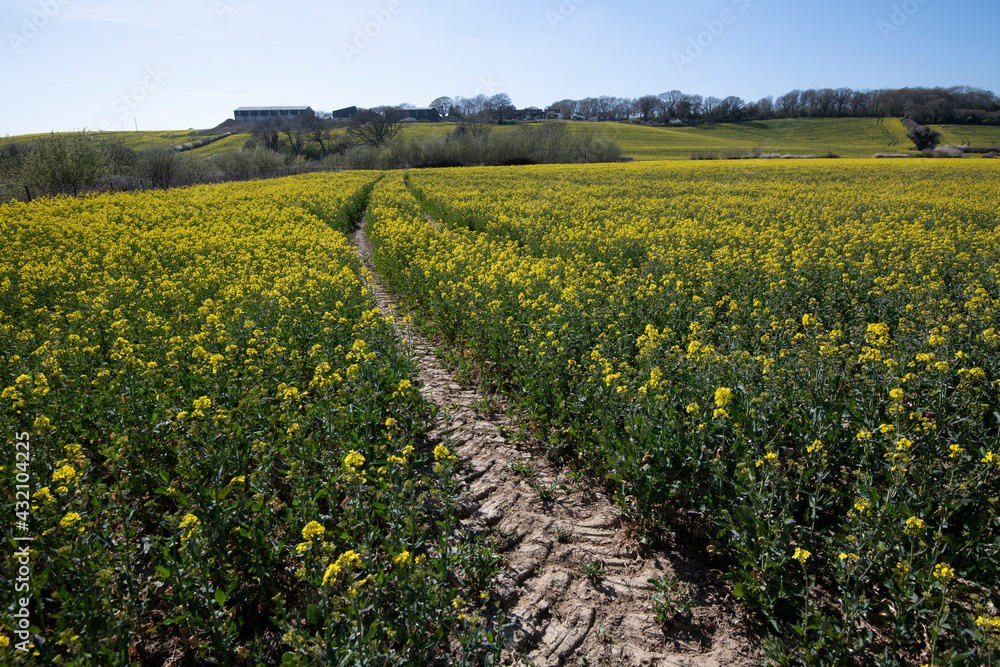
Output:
(0, 0), (1000, 135)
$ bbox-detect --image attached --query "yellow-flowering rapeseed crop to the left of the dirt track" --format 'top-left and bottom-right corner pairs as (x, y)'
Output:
(0, 172), (495, 665)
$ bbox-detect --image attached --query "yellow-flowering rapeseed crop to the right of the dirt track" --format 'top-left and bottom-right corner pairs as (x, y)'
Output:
(368, 160), (1000, 665)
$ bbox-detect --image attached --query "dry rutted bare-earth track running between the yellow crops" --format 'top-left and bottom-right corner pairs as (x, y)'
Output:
(354, 225), (754, 667)
